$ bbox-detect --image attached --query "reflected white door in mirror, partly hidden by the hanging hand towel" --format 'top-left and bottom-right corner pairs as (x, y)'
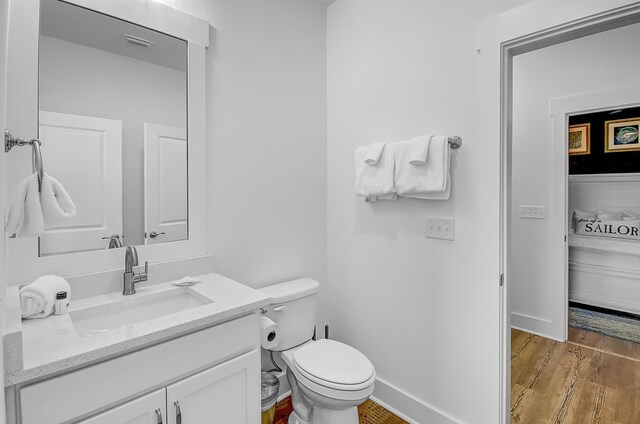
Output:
(40, 111), (122, 255)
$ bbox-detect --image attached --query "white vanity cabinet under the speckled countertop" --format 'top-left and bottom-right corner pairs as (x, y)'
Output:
(7, 313), (261, 424)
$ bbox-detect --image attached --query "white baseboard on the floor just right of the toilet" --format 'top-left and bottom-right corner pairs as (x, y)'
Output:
(371, 378), (461, 424)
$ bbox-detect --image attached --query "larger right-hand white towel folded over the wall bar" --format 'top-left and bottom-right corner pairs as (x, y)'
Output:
(395, 136), (451, 200)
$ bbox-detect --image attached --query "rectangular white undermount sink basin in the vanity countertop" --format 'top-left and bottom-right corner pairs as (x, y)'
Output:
(69, 288), (211, 336)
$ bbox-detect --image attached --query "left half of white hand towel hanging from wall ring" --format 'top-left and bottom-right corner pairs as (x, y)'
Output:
(6, 174), (44, 237)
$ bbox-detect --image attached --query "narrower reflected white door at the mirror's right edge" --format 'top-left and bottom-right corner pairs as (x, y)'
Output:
(144, 122), (187, 244)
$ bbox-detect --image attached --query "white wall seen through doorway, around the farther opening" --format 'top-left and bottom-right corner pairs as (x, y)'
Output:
(510, 24), (640, 334)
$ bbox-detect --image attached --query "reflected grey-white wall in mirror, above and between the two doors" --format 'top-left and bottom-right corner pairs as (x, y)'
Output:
(39, 36), (187, 245)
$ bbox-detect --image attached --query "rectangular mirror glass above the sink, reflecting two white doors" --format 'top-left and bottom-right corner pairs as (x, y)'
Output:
(38, 0), (189, 256)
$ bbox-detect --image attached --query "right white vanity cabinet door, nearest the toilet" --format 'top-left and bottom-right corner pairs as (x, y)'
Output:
(167, 350), (260, 424)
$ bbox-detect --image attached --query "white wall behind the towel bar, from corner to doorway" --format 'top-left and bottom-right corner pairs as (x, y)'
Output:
(324, 0), (522, 424)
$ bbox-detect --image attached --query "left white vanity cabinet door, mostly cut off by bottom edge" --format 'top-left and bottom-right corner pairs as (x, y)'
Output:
(78, 389), (167, 424)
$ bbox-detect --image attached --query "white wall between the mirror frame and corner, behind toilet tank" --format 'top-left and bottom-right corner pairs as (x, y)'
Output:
(155, 0), (327, 287)
